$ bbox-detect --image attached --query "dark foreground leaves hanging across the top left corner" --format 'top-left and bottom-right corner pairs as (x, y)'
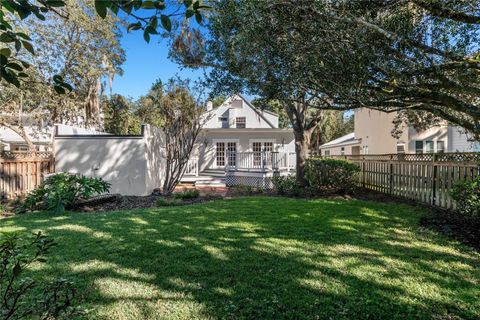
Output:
(0, 0), (209, 93)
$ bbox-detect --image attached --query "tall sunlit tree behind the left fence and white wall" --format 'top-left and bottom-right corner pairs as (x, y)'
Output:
(0, 0), (125, 149)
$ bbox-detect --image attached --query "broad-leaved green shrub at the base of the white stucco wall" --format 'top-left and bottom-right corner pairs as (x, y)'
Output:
(17, 173), (110, 214)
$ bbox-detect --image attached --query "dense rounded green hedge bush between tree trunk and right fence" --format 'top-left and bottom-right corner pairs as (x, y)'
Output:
(305, 158), (360, 195)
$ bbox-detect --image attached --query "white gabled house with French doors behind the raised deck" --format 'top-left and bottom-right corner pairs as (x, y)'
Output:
(191, 94), (295, 172)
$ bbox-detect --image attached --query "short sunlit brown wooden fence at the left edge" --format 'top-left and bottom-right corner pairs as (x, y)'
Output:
(0, 152), (55, 199)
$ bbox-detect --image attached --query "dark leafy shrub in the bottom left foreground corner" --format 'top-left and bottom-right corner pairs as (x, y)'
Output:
(0, 232), (80, 319)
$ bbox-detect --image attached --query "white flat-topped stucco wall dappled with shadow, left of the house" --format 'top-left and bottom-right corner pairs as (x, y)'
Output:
(54, 126), (164, 195)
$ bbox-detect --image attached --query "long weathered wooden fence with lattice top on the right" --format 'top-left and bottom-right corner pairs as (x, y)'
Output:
(324, 153), (480, 209)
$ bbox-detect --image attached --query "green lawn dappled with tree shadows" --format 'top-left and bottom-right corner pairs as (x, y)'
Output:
(0, 197), (480, 319)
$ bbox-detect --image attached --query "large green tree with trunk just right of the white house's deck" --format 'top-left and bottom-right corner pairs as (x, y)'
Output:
(178, 0), (367, 185)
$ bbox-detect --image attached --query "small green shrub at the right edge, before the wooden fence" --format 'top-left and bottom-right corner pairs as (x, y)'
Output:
(450, 177), (480, 223)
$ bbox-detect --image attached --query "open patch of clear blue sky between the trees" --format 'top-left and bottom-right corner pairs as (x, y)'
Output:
(111, 29), (207, 99)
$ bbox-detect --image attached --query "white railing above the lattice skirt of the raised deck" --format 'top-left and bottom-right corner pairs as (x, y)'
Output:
(225, 151), (296, 171)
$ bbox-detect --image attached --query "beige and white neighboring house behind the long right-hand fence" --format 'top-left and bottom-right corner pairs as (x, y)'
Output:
(320, 108), (480, 156)
